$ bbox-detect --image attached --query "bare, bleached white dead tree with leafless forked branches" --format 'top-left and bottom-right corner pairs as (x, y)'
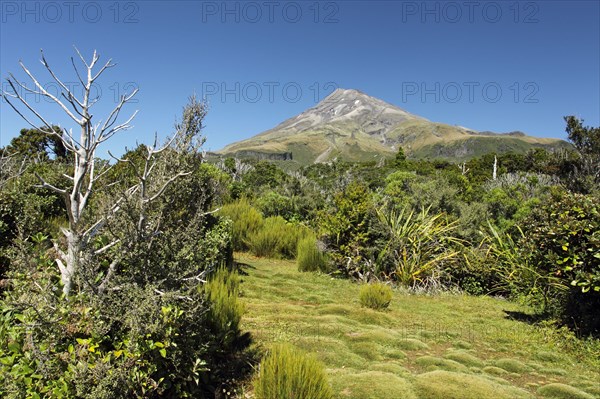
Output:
(2, 48), (138, 296)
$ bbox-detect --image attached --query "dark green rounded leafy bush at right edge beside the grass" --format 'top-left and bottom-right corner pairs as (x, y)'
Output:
(520, 192), (600, 333)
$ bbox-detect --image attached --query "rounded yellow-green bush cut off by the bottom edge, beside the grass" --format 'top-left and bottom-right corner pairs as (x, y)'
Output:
(254, 344), (333, 399)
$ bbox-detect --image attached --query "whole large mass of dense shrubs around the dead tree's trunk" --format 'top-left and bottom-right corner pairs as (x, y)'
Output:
(0, 97), (248, 398)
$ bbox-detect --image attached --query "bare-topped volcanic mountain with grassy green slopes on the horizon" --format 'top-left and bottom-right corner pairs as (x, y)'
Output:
(217, 89), (570, 164)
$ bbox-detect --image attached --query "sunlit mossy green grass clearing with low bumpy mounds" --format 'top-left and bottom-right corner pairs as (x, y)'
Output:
(237, 254), (600, 399)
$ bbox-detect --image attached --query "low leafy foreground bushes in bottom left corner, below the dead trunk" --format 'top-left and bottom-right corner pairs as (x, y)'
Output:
(0, 237), (247, 398)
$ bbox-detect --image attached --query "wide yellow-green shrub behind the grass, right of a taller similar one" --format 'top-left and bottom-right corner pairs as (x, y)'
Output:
(247, 216), (308, 259)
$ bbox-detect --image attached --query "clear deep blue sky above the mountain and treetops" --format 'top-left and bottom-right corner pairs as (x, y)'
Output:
(0, 0), (600, 153)
